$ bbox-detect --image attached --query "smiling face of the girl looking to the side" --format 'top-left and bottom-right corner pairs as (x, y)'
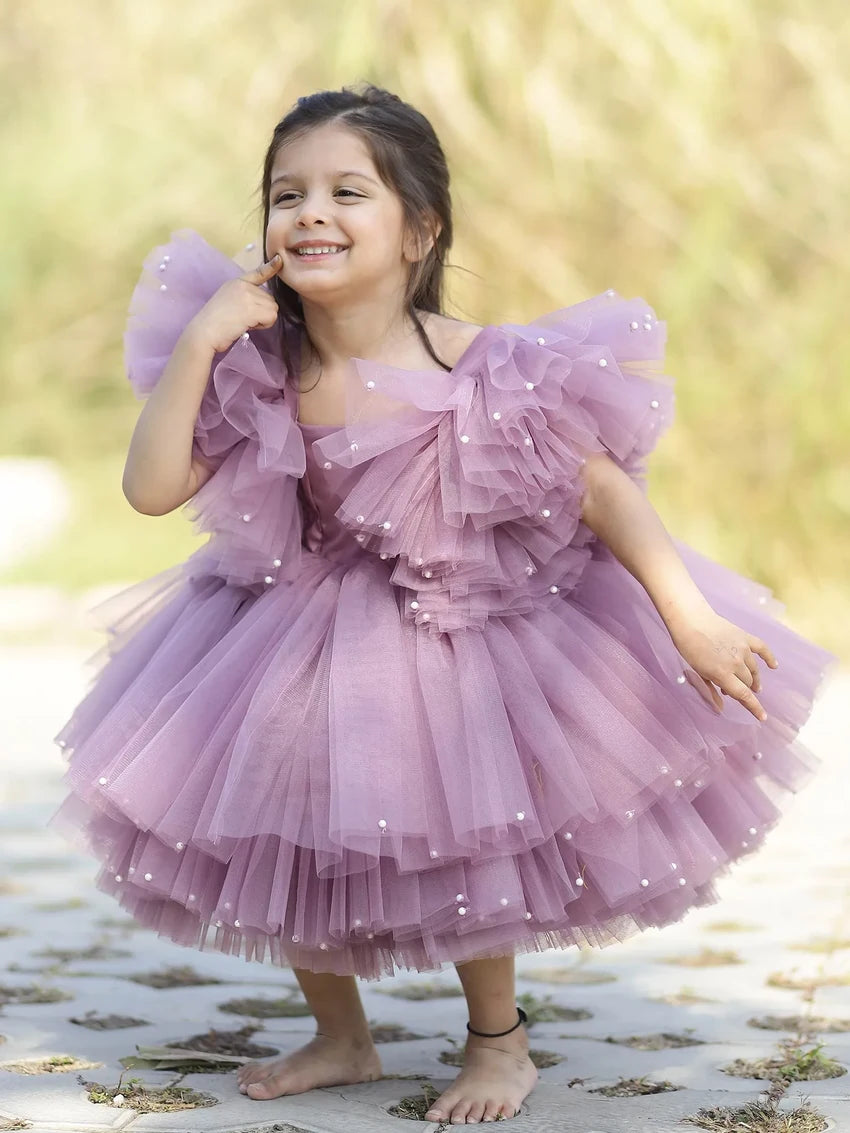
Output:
(265, 123), (417, 304)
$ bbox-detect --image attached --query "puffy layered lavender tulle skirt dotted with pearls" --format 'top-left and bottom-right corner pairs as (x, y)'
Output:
(51, 540), (836, 979)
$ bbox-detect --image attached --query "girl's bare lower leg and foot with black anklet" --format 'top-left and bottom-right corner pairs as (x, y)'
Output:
(425, 956), (537, 1125)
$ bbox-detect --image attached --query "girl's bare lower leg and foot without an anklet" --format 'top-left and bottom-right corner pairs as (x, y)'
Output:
(237, 968), (382, 1101)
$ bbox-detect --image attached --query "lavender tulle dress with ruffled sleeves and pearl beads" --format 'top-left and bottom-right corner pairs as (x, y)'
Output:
(51, 229), (838, 979)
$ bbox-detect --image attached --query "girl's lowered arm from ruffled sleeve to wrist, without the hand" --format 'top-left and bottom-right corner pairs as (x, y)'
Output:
(581, 452), (711, 629)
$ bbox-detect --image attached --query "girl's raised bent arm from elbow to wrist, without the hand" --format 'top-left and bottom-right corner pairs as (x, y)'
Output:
(121, 332), (214, 516)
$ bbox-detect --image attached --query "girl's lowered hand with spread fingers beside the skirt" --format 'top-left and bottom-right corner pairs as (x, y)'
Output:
(668, 608), (779, 721)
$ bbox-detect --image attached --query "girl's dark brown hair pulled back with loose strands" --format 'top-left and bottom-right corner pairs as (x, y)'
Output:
(258, 83), (452, 374)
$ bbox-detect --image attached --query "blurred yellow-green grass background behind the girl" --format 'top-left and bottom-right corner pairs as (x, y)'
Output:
(0, 0), (850, 649)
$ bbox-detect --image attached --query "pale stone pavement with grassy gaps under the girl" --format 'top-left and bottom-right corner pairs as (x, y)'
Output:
(0, 647), (850, 1133)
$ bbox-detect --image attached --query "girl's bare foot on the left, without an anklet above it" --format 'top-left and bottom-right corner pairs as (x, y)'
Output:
(236, 1034), (383, 1101)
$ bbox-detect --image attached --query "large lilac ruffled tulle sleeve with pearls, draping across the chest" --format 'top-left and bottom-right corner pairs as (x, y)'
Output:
(316, 291), (673, 632)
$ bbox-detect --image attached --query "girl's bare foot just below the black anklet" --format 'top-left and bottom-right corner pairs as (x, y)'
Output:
(425, 1026), (538, 1125)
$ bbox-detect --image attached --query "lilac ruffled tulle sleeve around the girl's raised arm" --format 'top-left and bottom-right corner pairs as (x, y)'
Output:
(125, 229), (306, 588)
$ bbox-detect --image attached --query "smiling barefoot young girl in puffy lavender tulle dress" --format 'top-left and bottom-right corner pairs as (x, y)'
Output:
(52, 86), (838, 1124)
